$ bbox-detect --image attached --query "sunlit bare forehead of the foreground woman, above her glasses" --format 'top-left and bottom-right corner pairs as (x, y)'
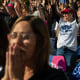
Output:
(12, 21), (33, 32)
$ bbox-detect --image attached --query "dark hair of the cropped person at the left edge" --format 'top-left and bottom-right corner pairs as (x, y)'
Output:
(0, 16), (10, 64)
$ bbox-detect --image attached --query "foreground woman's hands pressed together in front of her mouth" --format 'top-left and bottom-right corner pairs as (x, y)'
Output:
(1, 44), (25, 80)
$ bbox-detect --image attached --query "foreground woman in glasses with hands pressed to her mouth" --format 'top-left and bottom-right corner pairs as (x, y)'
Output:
(1, 16), (67, 80)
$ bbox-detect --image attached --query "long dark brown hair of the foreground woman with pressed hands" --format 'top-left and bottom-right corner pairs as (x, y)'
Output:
(12, 16), (50, 71)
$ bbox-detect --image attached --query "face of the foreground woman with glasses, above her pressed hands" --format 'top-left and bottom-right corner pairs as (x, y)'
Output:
(9, 21), (36, 60)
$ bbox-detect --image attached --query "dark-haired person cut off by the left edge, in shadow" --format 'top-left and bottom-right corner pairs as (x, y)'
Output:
(0, 16), (9, 78)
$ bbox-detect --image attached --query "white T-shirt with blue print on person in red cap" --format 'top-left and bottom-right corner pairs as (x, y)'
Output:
(57, 20), (79, 51)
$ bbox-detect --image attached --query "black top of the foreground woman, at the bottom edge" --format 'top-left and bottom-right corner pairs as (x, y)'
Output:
(29, 67), (67, 80)
